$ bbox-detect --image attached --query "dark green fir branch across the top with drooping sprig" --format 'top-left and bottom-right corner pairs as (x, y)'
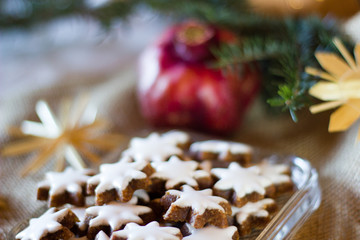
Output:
(0, 0), (351, 121)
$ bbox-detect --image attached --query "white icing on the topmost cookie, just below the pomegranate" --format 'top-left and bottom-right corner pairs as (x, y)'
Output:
(122, 132), (183, 162)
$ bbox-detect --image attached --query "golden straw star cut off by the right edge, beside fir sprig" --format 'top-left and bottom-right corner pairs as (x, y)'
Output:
(305, 39), (360, 140)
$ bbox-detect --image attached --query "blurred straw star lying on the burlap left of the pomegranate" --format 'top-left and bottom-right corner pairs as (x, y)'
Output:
(2, 95), (124, 176)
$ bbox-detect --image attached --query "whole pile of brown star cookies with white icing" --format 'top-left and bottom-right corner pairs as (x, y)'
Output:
(16, 131), (293, 240)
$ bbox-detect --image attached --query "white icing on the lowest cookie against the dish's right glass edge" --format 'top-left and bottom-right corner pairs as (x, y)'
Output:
(231, 198), (275, 224)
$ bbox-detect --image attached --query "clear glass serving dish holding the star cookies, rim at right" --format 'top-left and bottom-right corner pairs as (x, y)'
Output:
(7, 149), (321, 240)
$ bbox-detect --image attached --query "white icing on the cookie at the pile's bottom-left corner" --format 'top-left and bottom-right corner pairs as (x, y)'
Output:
(15, 208), (69, 240)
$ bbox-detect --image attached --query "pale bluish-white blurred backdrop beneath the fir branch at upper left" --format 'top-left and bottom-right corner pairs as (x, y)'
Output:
(0, 0), (165, 98)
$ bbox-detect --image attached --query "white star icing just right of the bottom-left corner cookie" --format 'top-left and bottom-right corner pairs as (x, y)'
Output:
(86, 198), (152, 231)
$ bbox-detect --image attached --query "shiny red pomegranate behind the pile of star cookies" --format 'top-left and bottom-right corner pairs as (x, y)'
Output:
(138, 21), (260, 133)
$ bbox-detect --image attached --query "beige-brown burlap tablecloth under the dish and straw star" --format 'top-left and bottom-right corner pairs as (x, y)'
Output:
(0, 64), (360, 239)
